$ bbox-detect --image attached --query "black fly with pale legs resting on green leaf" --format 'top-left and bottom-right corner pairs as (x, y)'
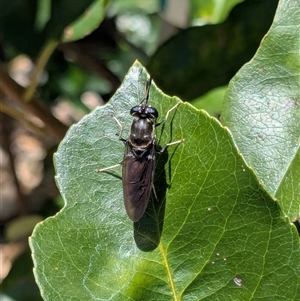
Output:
(97, 78), (183, 222)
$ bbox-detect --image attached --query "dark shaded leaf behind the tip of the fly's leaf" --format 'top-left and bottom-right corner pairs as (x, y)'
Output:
(148, 0), (277, 100)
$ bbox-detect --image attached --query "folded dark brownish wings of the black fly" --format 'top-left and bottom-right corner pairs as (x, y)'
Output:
(122, 144), (155, 222)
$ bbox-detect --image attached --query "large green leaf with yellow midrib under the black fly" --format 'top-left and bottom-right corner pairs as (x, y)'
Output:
(30, 63), (300, 300)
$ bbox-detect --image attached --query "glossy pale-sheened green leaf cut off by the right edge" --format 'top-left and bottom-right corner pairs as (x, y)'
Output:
(222, 0), (300, 220)
